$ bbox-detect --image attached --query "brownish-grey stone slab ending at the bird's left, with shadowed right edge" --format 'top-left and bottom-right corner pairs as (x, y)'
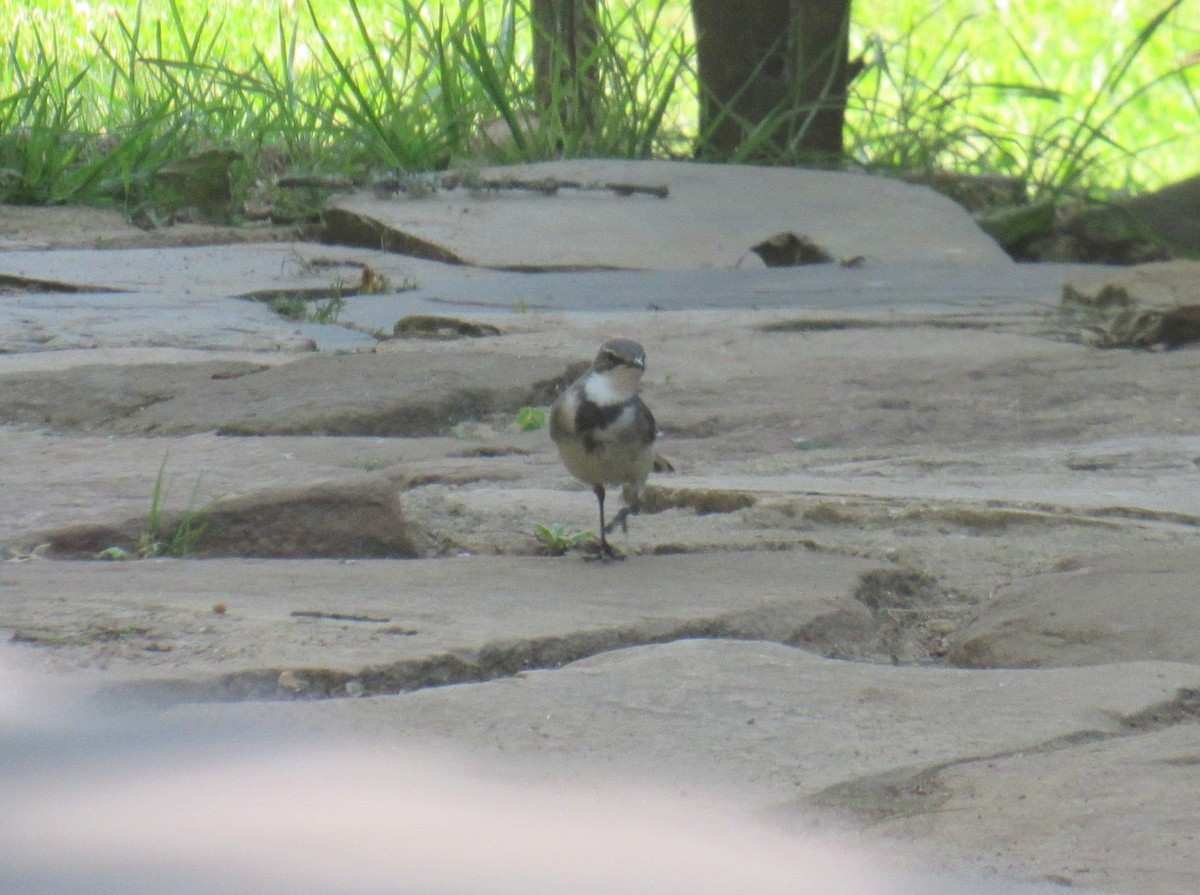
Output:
(0, 342), (566, 437)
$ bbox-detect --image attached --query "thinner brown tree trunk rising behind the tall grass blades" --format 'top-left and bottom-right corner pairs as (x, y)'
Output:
(533, 0), (599, 130)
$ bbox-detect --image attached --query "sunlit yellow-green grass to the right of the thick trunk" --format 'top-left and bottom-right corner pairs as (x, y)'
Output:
(850, 0), (1200, 190)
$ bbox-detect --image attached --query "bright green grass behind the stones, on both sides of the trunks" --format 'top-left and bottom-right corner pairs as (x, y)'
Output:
(0, 0), (1200, 206)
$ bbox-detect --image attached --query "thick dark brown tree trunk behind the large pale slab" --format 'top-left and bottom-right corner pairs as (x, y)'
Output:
(692, 0), (862, 162)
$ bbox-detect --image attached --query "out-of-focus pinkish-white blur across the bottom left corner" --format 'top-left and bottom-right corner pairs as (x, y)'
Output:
(0, 650), (1104, 895)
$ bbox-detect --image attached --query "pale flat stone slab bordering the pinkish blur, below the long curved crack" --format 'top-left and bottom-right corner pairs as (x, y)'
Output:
(176, 639), (1200, 811)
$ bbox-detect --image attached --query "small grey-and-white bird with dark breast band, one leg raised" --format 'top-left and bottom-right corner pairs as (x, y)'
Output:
(550, 338), (658, 560)
